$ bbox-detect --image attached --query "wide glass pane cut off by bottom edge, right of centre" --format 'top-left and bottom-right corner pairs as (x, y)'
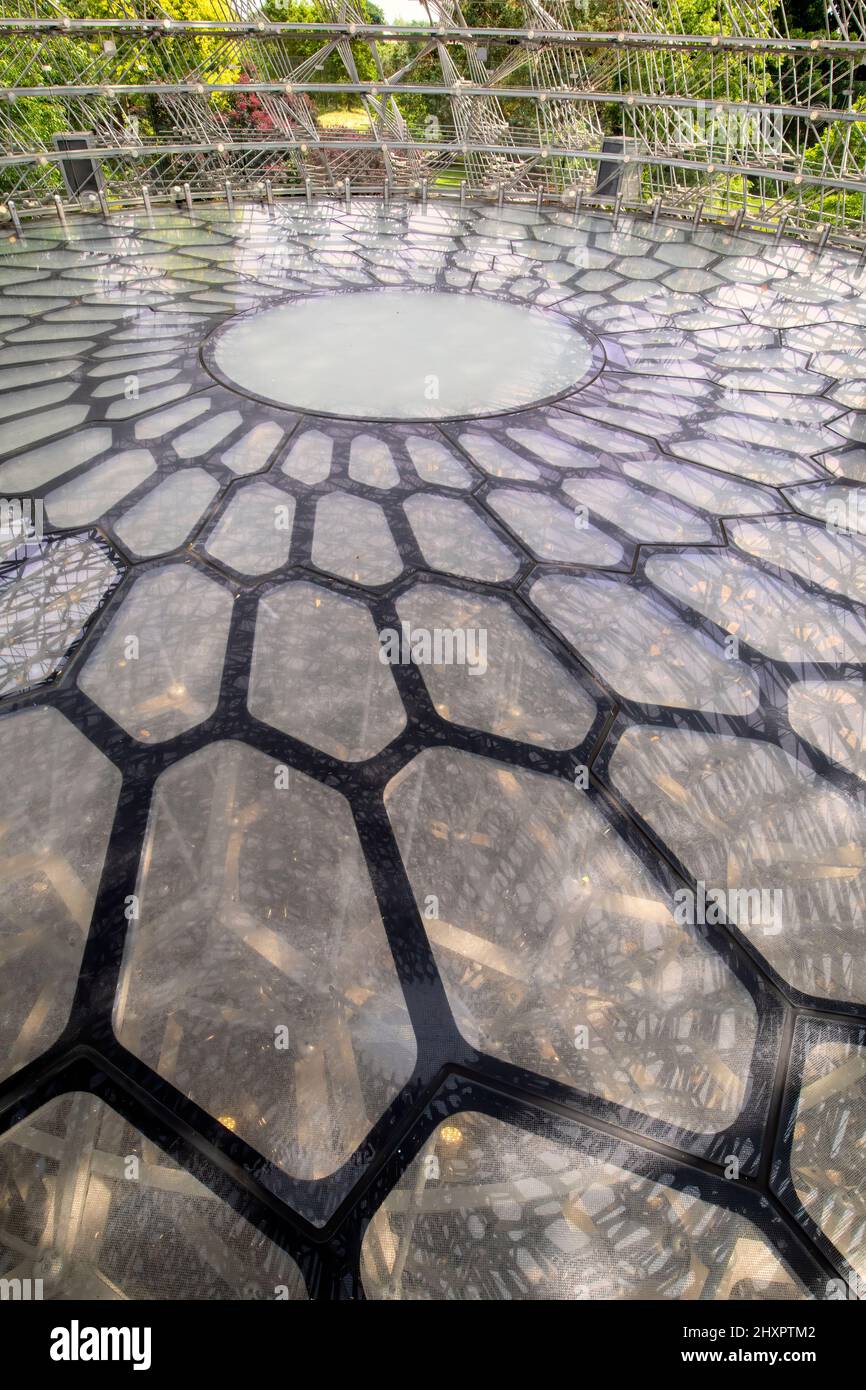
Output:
(361, 1111), (809, 1301)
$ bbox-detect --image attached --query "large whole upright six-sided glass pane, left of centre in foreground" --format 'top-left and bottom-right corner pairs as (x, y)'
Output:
(115, 741), (416, 1195)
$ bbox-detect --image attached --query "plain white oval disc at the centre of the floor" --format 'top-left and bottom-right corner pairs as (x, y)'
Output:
(206, 289), (594, 420)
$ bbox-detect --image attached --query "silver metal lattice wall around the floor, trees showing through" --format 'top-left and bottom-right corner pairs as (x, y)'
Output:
(0, 0), (866, 235)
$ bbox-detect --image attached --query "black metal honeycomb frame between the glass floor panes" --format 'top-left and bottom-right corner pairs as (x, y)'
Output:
(0, 198), (866, 1300)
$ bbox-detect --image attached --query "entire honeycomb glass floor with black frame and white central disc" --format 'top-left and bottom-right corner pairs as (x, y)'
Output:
(0, 199), (866, 1300)
